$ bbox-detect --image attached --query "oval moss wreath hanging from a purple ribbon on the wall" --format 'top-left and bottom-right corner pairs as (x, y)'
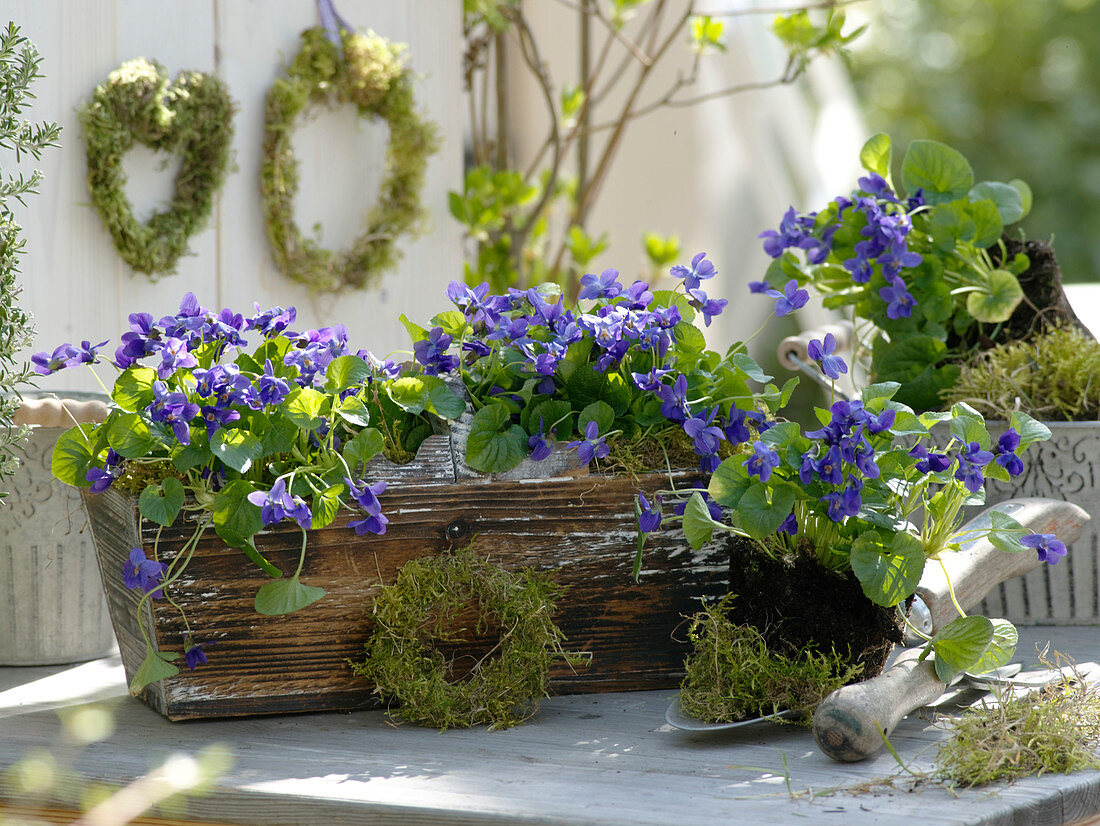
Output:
(260, 27), (439, 291)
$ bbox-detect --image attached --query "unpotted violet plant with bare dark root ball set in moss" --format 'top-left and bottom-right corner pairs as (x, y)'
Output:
(642, 318), (1066, 722)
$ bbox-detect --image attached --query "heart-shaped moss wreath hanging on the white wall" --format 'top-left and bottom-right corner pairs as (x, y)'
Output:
(79, 57), (237, 278)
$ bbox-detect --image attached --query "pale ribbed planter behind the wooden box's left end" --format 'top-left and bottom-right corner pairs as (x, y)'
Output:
(0, 398), (114, 665)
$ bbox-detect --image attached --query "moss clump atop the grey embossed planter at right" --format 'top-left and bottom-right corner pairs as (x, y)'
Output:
(946, 327), (1100, 421)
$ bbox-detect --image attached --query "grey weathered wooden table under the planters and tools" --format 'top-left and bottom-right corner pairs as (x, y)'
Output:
(0, 627), (1100, 826)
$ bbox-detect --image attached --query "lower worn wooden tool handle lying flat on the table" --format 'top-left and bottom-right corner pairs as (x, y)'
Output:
(814, 648), (944, 762)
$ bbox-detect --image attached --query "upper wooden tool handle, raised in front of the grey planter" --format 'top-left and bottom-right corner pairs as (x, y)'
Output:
(916, 498), (1089, 631)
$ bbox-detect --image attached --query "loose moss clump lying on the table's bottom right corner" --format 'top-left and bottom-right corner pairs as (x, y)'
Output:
(936, 655), (1100, 788)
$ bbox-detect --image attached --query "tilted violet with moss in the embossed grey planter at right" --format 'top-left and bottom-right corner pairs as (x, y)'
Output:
(752, 134), (1100, 623)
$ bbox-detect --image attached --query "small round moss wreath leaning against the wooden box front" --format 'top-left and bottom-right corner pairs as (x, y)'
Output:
(353, 548), (562, 729)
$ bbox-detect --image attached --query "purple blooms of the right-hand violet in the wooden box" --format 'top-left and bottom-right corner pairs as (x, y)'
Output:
(424, 253), (778, 483)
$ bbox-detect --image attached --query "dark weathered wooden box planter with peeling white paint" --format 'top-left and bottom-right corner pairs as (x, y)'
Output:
(85, 436), (729, 719)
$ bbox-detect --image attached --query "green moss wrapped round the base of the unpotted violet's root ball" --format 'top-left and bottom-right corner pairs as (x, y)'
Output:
(680, 594), (862, 723)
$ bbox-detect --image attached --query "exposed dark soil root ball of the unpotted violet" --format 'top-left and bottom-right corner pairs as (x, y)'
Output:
(729, 537), (902, 680)
